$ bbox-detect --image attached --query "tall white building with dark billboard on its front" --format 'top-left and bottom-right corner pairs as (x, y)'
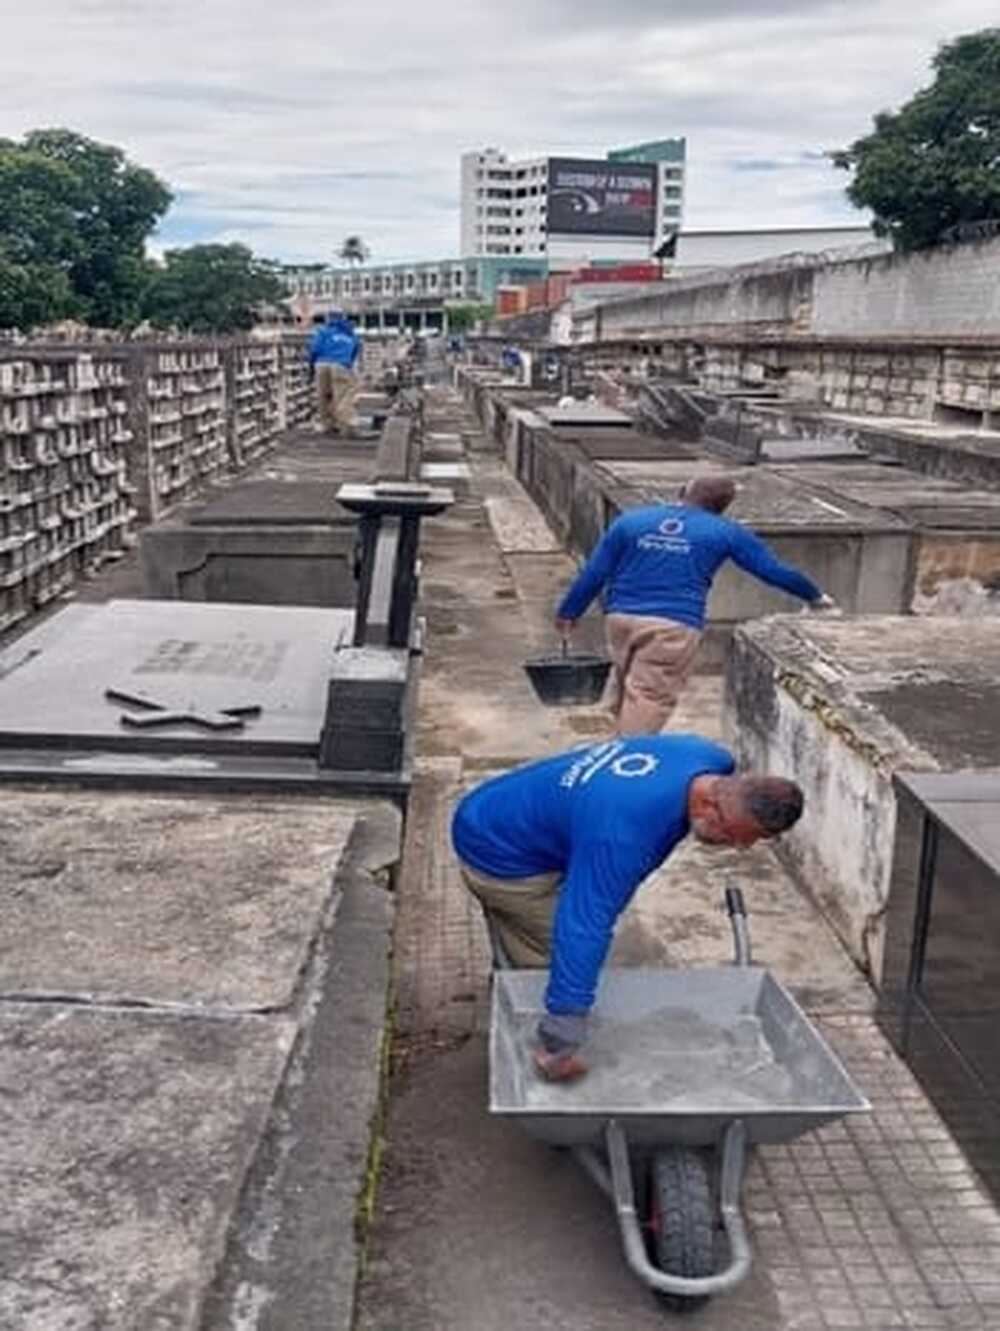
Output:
(461, 138), (686, 270)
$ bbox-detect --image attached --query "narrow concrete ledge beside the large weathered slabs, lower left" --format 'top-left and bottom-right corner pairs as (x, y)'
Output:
(201, 805), (402, 1331)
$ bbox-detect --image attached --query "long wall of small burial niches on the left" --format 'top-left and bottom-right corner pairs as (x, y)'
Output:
(0, 335), (312, 631)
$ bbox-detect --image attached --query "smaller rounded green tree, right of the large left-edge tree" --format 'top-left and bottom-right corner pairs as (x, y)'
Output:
(144, 245), (288, 333)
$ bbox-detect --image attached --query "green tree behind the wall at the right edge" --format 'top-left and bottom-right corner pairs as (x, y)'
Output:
(832, 28), (1000, 250)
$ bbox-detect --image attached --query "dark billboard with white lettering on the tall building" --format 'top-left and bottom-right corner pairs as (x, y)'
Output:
(549, 157), (656, 236)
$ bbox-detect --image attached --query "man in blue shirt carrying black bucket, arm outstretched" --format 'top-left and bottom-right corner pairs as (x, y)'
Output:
(555, 475), (834, 735)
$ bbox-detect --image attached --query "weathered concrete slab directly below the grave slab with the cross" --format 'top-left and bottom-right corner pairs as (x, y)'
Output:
(0, 791), (358, 1013)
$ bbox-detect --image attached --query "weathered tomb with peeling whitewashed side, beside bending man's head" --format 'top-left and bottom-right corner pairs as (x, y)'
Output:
(726, 616), (1000, 981)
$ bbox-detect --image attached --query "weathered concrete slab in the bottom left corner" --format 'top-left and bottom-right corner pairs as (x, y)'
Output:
(0, 1004), (296, 1331)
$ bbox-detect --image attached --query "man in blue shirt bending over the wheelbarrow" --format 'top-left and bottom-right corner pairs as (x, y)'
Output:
(451, 735), (803, 1081)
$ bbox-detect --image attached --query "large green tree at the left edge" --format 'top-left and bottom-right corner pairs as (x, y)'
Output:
(0, 129), (170, 330)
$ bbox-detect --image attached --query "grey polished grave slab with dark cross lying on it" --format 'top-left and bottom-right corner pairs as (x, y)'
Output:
(0, 600), (410, 787)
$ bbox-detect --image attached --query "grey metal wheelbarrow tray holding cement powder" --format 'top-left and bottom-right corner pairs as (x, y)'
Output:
(490, 966), (870, 1146)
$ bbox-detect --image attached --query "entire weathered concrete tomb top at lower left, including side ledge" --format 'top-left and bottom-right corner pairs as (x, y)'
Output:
(0, 729), (399, 1331)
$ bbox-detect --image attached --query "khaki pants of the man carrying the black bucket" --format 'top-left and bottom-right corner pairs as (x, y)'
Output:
(605, 615), (702, 735)
